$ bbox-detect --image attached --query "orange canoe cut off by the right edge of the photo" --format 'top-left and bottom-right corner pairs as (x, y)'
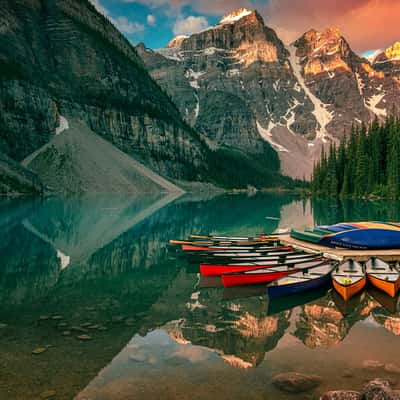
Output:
(365, 258), (400, 297)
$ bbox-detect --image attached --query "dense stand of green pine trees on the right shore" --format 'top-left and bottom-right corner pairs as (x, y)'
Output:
(311, 116), (400, 199)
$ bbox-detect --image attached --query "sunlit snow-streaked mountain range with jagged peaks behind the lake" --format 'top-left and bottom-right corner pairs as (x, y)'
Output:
(137, 9), (399, 178)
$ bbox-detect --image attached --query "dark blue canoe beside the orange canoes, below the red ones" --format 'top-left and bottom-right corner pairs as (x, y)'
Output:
(268, 260), (335, 298)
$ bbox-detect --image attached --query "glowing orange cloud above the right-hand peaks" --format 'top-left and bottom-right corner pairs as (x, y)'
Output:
(264, 0), (400, 53)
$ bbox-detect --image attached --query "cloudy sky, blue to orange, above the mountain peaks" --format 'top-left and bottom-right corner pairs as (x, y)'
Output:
(90, 0), (400, 54)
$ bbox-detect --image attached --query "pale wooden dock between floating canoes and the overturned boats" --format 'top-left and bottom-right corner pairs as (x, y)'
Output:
(280, 235), (400, 262)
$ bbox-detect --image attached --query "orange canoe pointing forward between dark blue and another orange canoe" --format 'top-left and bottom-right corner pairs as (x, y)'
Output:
(332, 260), (367, 301)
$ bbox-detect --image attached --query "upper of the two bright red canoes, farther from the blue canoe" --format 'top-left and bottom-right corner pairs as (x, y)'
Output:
(200, 254), (321, 276)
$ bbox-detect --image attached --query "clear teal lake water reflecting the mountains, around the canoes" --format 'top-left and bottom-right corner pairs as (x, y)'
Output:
(0, 194), (400, 400)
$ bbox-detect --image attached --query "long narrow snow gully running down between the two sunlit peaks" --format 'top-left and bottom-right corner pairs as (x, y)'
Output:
(288, 45), (333, 142)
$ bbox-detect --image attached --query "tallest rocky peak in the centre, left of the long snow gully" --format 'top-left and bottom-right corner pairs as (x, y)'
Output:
(146, 10), (310, 158)
